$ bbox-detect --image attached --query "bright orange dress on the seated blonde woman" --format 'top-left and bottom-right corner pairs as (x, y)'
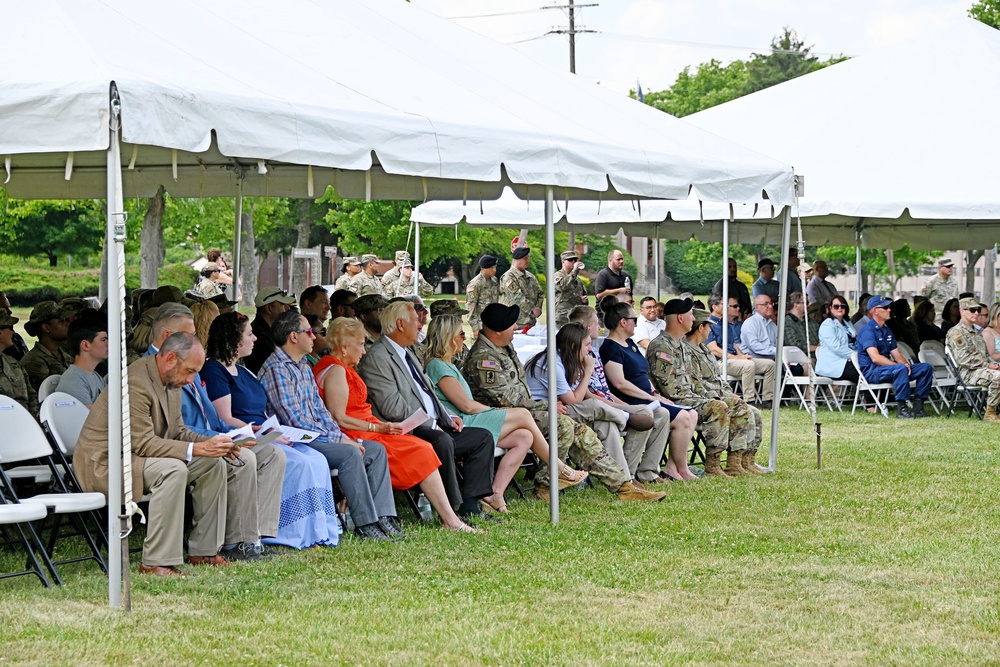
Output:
(313, 354), (441, 491)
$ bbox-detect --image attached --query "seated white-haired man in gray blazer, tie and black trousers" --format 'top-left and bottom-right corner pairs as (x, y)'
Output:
(358, 301), (495, 519)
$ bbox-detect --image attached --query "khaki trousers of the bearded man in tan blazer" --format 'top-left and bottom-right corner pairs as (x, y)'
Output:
(142, 456), (227, 567)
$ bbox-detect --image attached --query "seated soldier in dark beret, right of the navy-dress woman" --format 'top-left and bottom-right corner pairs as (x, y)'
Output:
(646, 299), (747, 477)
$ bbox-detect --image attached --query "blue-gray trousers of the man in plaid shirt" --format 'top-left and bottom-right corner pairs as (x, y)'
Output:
(305, 440), (396, 526)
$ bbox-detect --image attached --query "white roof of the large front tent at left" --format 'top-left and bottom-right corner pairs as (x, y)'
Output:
(0, 0), (792, 204)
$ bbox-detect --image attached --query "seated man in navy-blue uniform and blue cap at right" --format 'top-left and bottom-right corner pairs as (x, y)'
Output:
(858, 294), (934, 419)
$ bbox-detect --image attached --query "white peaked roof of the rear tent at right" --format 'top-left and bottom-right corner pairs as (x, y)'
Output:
(685, 19), (1000, 248)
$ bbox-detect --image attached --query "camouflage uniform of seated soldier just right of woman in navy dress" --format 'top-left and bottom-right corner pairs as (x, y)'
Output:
(646, 331), (747, 454)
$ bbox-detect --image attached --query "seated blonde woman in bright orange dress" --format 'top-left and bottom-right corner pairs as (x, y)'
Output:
(313, 317), (485, 533)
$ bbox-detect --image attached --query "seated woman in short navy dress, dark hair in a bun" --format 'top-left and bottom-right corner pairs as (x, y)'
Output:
(600, 296), (698, 479)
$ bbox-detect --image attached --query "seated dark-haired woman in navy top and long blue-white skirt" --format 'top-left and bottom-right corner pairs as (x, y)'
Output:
(201, 312), (341, 549)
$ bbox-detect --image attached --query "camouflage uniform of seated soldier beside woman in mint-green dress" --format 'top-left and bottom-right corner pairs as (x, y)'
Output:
(462, 336), (631, 492)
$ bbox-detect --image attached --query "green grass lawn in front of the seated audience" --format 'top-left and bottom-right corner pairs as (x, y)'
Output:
(0, 409), (1000, 665)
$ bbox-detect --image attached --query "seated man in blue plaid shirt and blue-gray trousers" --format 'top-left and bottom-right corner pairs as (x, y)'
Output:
(260, 312), (403, 541)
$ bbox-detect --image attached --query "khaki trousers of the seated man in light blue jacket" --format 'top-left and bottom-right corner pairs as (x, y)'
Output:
(226, 443), (285, 544)
